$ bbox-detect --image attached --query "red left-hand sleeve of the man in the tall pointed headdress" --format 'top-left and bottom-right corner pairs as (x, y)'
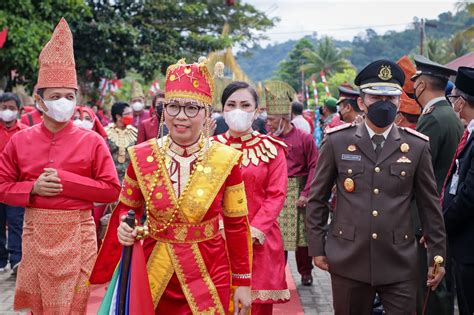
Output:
(0, 136), (35, 207)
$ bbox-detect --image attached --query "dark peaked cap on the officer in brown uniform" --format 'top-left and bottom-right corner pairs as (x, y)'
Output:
(354, 59), (405, 95)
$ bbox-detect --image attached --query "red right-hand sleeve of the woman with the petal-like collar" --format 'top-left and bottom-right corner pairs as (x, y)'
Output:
(250, 146), (288, 234)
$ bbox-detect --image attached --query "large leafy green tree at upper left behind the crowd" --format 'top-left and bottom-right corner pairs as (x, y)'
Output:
(0, 0), (276, 93)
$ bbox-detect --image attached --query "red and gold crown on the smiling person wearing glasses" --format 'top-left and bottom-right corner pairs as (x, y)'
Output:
(165, 59), (214, 105)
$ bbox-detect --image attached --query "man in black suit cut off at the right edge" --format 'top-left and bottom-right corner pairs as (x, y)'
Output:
(442, 67), (474, 315)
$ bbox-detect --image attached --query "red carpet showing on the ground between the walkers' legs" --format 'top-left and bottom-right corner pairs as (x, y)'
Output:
(87, 266), (304, 315)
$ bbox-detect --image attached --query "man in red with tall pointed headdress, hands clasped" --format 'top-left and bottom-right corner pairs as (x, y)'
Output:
(0, 19), (120, 314)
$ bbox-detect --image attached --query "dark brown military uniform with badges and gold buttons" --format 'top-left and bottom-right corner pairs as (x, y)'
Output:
(306, 123), (446, 314)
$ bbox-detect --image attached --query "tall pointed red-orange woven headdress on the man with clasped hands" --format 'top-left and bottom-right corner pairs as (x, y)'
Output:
(36, 18), (77, 89)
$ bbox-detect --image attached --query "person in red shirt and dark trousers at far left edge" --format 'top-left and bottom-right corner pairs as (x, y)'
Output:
(0, 93), (27, 275)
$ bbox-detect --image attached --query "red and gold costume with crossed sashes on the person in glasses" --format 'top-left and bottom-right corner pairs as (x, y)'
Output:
(91, 137), (251, 314)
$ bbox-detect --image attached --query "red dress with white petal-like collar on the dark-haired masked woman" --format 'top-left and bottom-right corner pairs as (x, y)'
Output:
(214, 131), (290, 303)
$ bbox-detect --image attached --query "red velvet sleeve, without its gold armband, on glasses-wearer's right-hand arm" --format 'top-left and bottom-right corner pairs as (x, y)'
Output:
(223, 163), (252, 286)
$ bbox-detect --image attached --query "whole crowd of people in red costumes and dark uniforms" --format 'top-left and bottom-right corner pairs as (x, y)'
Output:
(0, 19), (474, 315)
